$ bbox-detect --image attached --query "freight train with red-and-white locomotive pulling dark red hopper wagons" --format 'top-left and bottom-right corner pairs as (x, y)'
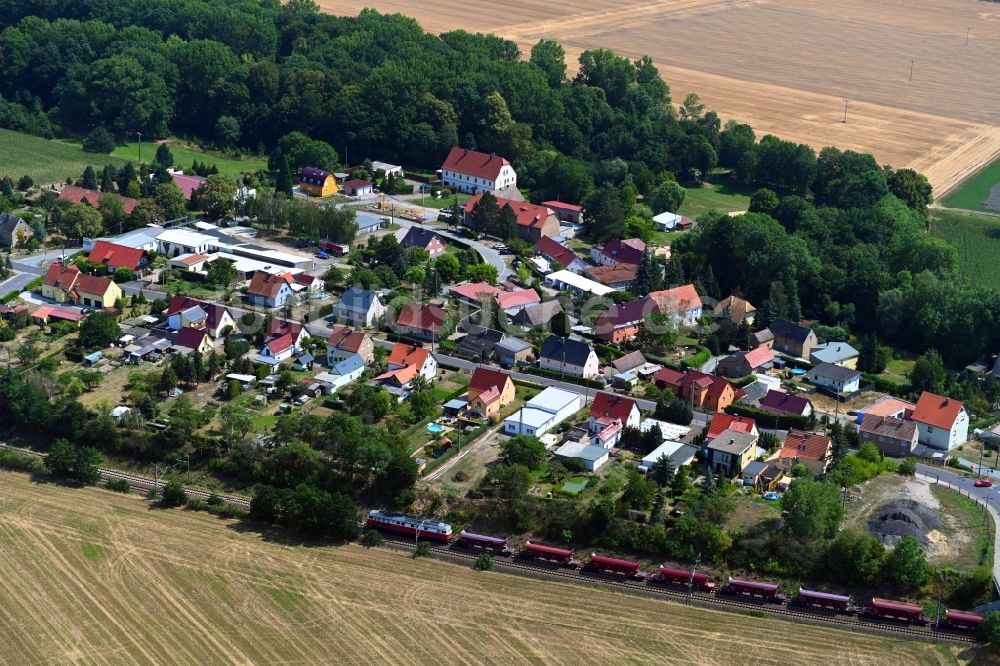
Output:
(366, 510), (983, 631)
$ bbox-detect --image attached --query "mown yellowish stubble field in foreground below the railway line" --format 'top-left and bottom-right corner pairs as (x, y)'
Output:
(0, 472), (968, 666)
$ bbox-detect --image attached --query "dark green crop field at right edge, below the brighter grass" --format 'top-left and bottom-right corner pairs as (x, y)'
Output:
(931, 212), (1000, 287)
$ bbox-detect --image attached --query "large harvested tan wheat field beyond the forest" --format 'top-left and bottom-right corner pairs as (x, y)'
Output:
(320, 0), (1000, 196)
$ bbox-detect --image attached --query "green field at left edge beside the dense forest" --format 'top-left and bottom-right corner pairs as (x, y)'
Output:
(0, 129), (122, 185)
